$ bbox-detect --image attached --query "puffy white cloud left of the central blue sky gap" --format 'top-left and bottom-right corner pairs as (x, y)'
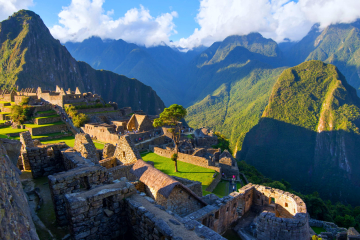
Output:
(50, 0), (178, 46)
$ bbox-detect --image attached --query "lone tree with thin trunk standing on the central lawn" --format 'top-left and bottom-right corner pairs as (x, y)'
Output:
(153, 104), (186, 172)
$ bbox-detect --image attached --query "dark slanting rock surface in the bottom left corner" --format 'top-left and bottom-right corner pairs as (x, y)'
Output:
(0, 145), (39, 240)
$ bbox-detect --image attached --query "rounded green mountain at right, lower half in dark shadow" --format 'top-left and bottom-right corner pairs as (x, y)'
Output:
(238, 61), (360, 204)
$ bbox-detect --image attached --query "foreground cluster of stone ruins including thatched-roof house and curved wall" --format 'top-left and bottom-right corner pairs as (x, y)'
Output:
(2, 129), (318, 240)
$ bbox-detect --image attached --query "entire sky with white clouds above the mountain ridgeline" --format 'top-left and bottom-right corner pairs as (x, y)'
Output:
(0, 0), (360, 49)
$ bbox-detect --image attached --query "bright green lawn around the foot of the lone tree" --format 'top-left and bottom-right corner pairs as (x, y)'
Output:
(141, 153), (215, 196)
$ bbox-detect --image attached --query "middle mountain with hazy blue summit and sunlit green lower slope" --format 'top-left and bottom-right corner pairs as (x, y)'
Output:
(184, 33), (285, 152)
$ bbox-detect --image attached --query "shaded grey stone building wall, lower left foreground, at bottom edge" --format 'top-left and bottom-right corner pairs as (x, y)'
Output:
(65, 179), (136, 239)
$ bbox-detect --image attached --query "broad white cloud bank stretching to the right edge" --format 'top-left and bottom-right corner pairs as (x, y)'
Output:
(174, 0), (360, 48)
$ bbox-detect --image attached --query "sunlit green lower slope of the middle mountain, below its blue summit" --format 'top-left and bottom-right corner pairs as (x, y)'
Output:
(186, 62), (283, 150)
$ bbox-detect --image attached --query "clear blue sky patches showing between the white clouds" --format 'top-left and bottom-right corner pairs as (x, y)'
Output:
(29, 0), (200, 41)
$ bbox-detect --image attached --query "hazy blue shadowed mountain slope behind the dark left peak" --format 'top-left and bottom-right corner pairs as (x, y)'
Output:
(65, 37), (185, 105)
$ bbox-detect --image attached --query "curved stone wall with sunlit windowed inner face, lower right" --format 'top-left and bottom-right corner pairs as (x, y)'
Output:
(239, 183), (310, 240)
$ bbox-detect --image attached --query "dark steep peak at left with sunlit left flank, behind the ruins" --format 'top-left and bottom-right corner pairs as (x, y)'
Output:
(0, 10), (165, 114)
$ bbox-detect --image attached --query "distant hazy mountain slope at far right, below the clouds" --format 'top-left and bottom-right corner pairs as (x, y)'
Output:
(285, 20), (360, 95)
